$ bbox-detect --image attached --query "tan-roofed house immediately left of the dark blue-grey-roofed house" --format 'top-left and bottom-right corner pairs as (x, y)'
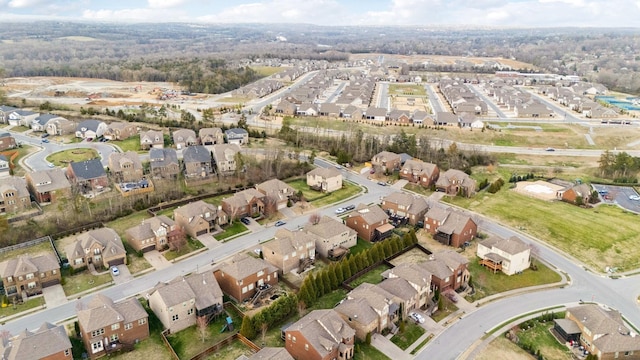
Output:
(25, 169), (71, 204)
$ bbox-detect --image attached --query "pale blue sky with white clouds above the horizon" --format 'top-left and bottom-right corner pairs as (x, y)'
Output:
(0, 0), (640, 27)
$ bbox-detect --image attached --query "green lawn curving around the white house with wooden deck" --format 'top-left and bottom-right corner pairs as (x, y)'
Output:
(467, 259), (562, 302)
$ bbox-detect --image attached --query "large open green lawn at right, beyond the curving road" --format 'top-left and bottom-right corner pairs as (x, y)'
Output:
(444, 187), (640, 271)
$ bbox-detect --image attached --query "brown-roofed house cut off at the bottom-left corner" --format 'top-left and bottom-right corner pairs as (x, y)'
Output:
(0, 322), (73, 360)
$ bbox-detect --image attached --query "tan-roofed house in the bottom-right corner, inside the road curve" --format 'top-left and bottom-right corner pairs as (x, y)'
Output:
(565, 304), (640, 360)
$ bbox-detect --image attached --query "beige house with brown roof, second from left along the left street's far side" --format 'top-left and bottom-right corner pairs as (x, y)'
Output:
(65, 228), (127, 269)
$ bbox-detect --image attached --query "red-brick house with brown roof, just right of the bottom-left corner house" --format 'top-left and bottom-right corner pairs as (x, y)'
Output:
(78, 294), (149, 359)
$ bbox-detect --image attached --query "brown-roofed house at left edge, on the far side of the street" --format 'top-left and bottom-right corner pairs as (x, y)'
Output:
(0, 254), (61, 300)
